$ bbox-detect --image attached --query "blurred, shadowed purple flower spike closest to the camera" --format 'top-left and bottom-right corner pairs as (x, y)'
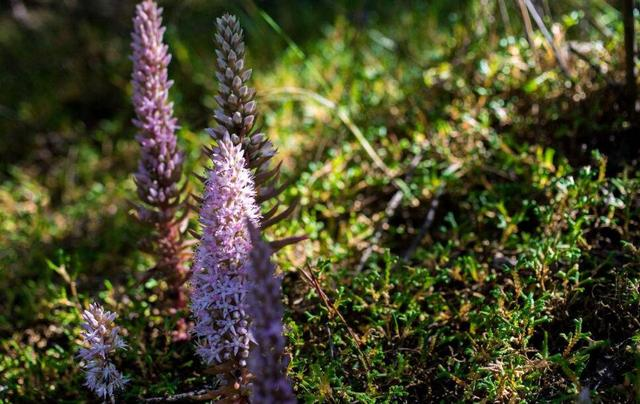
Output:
(247, 225), (296, 404)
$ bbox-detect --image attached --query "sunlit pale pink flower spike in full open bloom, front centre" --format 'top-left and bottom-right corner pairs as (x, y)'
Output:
(191, 135), (260, 393)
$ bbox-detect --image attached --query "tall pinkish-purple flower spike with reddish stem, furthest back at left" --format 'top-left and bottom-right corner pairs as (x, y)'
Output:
(132, 0), (189, 307)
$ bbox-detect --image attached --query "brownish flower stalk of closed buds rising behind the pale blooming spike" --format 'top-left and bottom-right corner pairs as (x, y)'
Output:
(208, 14), (303, 247)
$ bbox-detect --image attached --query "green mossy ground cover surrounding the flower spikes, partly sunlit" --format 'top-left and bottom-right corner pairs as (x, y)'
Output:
(0, 0), (640, 403)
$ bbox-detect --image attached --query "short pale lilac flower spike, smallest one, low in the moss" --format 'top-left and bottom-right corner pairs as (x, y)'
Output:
(78, 303), (127, 400)
